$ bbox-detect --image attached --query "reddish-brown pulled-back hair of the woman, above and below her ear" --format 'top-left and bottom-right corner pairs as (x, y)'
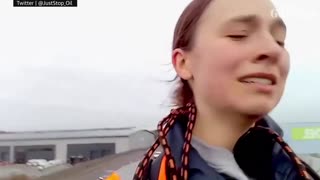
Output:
(172, 0), (212, 106)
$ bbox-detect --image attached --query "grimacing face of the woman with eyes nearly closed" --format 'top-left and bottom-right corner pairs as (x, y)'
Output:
(174, 0), (289, 115)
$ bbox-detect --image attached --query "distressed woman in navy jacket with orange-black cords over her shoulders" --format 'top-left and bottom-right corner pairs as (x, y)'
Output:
(134, 0), (320, 180)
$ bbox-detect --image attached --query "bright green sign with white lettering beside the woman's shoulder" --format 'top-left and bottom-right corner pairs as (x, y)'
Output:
(291, 127), (320, 140)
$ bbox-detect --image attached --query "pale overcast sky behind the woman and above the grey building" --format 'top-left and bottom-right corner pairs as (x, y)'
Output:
(0, 0), (320, 131)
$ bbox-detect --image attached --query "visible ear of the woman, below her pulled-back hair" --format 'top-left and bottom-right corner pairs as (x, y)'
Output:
(172, 49), (192, 80)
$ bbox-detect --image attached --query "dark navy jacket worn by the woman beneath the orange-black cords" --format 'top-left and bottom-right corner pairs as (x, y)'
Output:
(149, 117), (314, 180)
